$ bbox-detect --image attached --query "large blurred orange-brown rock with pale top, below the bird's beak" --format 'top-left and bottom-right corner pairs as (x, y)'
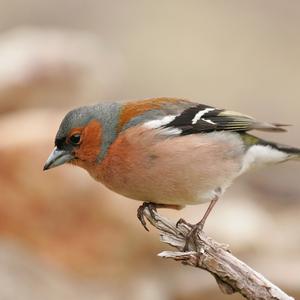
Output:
(0, 110), (158, 275)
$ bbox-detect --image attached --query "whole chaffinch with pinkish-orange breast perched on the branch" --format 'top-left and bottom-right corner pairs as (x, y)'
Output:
(44, 97), (300, 250)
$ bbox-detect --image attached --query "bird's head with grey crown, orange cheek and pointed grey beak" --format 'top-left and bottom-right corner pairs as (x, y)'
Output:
(44, 106), (102, 170)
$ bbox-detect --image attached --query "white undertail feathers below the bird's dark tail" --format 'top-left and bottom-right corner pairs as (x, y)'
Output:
(240, 145), (289, 174)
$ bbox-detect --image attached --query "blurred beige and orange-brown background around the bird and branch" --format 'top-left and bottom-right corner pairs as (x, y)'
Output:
(0, 0), (300, 300)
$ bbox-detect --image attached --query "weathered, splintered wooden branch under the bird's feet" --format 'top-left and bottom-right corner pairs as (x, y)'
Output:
(144, 208), (294, 300)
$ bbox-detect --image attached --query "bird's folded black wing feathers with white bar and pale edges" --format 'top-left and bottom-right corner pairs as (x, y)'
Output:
(164, 104), (286, 135)
